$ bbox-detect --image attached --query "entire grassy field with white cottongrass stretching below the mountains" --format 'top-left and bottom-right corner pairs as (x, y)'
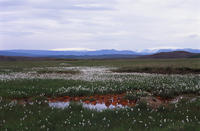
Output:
(0, 58), (200, 131)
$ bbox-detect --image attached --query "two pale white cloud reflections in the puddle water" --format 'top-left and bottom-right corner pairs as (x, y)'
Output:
(49, 102), (126, 111)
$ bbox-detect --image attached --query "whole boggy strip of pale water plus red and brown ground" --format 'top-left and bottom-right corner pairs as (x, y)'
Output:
(13, 94), (197, 111)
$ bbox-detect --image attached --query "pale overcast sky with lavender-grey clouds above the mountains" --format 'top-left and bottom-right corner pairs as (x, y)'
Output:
(0, 0), (200, 50)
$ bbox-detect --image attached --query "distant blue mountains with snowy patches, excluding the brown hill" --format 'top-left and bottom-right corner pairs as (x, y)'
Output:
(0, 48), (200, 57)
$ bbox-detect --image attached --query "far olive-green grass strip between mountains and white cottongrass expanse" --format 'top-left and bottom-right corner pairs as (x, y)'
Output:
(0, 58), (200, 69)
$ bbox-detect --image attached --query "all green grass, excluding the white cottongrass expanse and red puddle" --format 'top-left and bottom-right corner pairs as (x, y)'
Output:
(0, 59), (200, 131)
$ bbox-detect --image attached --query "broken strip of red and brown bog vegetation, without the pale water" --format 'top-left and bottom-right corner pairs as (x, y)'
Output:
(12, 94), (188, 108)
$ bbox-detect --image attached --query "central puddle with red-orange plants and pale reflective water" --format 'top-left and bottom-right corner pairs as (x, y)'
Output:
(49, 94), (136, 111)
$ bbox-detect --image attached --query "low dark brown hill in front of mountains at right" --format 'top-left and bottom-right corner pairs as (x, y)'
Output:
(140, 51), (197, 59)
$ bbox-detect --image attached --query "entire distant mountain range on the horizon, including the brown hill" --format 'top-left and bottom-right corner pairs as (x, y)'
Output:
(0, 49), (200, 59)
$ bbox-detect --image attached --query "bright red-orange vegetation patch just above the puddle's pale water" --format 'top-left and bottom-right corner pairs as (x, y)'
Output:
(49, 94), (136, 107)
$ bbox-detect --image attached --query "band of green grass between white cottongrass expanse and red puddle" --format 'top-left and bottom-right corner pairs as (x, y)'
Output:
(0, 75), (200, 98)
